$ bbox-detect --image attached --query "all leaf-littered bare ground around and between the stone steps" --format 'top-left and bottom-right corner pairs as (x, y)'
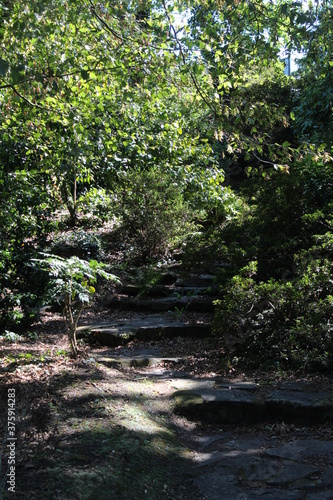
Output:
(0, 309), (333, 500)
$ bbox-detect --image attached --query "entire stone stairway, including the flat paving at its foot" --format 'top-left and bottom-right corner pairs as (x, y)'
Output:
(79, 264), (333, 500)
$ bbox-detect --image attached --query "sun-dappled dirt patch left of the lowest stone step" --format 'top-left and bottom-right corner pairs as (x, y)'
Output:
(1, 324), (204, 499)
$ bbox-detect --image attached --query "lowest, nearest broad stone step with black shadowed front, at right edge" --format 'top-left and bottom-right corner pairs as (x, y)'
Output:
(174, 384), (333, 425)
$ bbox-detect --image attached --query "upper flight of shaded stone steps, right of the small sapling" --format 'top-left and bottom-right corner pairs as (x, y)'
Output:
(78, 272), (217, 347)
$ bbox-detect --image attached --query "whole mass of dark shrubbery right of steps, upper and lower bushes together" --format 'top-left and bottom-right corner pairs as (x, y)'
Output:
(209, 157), (333, 371)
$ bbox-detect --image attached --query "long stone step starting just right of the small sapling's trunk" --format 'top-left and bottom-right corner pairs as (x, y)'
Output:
(78, 316), (211, 347)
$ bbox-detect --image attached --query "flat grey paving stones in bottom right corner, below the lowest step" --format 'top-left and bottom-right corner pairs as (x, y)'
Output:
(189, 433), (333, 500)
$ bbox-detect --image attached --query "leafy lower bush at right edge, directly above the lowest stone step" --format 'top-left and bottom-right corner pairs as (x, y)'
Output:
(214, 246), (333, 371)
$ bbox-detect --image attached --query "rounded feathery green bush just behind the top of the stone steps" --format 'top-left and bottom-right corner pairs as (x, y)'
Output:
(116, 168), (194, 260)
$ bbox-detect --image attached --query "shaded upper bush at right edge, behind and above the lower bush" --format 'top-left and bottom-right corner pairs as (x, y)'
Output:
(192, 159), (333, 284)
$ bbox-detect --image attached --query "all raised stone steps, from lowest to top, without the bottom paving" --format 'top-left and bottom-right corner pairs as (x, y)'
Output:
(78, 270), (333, 425)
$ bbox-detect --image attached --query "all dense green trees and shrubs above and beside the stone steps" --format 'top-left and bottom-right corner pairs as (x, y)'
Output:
(0, 0), (333, 369)
